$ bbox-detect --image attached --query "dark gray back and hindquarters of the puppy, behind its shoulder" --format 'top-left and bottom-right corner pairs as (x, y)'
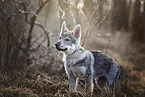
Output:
(92, 52), (120, 90)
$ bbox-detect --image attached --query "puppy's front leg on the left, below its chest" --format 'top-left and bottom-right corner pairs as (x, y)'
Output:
(69, 71), (78, 91)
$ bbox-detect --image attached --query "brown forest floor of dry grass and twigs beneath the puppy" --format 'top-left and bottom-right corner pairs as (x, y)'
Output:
(0, 52), (145, 97)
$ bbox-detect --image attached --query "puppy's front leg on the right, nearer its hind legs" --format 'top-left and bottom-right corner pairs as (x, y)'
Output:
(85, 75), (94, 93)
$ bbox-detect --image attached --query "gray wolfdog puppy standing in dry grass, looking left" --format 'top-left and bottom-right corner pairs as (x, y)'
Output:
(55, 21), (120, 93)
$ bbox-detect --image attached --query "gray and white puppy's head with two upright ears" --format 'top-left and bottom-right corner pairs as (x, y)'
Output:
(55, 21), (81, 53)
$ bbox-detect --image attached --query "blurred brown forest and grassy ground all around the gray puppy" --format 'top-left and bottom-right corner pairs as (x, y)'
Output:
(0, 0), (145, 97)
